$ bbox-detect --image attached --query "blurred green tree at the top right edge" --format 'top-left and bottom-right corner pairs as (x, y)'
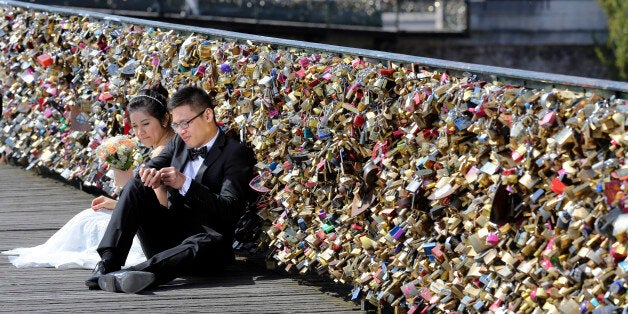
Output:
(595, 0), (628, 81)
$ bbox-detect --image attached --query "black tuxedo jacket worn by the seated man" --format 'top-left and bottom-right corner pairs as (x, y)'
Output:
(146, 131), (255, 240)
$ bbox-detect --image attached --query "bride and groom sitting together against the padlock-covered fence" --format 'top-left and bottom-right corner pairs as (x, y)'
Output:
(3, 84), (255, 293)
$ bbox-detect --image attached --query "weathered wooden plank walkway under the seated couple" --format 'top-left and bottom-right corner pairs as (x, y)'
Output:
(0, 164), (360, 313)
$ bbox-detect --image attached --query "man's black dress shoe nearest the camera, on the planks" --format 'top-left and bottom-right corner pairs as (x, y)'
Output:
(98, 269), (155, 293)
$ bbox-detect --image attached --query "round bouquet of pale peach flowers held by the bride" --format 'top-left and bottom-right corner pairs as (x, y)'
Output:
(96, 135), (138, 170)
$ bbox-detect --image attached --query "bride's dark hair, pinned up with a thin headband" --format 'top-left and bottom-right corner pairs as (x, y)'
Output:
(128, 83), (171, 127)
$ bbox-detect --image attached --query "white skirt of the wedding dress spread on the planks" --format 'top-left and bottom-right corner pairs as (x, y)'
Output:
(2, 208), (146, 269)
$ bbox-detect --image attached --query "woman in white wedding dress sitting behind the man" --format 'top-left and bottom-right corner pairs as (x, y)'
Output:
(2, 84), (174, 269)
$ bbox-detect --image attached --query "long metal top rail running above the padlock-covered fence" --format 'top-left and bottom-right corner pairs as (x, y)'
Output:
(0, 0), (628, 99)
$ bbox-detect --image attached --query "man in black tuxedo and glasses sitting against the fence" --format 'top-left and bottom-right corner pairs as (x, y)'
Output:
(85, 87), (254, 293)
